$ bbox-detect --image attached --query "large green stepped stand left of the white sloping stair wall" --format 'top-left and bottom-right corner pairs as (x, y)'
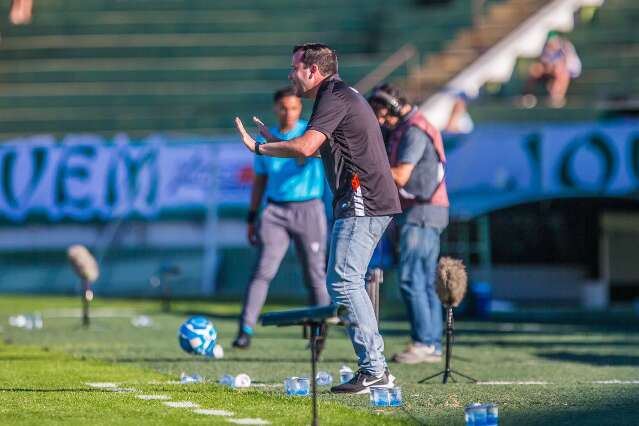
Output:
(0, 0), (496, 140)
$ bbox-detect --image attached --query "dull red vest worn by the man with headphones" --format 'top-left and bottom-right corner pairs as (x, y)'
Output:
(388, 111), (450, 208)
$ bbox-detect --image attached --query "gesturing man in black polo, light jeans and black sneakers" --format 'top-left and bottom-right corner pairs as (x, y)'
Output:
(235, 43), (401, 393)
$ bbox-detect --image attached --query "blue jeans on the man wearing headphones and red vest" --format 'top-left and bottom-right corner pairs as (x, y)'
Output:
(399, 223), (443, 350)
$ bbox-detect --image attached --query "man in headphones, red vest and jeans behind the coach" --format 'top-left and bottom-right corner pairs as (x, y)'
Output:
(368, 84), (449, 364)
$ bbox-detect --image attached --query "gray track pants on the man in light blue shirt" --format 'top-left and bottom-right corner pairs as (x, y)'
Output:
(240, 199), (331, 329)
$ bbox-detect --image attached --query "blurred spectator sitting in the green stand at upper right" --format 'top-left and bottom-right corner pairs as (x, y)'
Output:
(521, 31), (581, 108)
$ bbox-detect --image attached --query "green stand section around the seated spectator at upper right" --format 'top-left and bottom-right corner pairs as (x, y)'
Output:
(469, 0), (639, 122)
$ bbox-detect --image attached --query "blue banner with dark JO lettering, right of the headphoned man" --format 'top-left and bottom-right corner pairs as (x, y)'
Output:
(446, 121), (639, 218)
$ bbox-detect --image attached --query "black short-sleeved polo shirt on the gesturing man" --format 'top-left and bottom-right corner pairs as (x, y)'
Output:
(307, 76), (402, 219)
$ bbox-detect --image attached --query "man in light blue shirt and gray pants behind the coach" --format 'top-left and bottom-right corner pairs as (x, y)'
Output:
(233, 88), (331, 348)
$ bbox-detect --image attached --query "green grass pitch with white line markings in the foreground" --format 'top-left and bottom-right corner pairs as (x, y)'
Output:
(0, 295), (639, 425)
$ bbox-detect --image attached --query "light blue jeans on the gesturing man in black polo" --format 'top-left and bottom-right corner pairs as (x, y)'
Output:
(326, 216), (391, 376)
